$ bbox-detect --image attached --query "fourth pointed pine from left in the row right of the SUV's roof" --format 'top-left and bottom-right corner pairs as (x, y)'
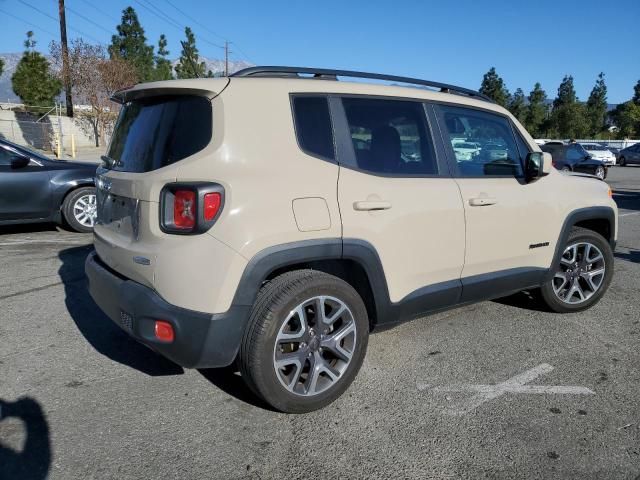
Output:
(551, 75), (588, 138)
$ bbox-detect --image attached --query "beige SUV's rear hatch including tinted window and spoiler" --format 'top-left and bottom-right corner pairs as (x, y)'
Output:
(94, 79), (226, 287)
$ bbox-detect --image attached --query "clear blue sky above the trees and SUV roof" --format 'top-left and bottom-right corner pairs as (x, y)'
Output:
(0, 0), (640, 103)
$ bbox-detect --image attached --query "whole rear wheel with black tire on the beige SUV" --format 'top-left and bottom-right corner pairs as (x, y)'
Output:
(238, 270), (369, 413)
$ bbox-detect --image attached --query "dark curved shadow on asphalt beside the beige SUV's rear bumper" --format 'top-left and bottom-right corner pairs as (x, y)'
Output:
(58, 245), (184, 376)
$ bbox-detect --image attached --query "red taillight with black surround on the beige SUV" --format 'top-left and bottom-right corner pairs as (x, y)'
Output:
(160, 182), (224, 235)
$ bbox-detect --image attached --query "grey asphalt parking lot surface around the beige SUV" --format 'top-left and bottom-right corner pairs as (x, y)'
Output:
(0, 167), (640, 480)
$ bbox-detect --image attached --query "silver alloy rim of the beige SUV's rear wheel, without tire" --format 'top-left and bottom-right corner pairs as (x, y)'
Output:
(273, 296), (356, 397)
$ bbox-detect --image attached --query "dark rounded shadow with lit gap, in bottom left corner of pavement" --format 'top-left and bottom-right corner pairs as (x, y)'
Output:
(0, 397), (51, 480)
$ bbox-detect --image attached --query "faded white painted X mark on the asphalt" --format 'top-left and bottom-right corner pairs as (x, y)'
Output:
(417, 363), (595, 415)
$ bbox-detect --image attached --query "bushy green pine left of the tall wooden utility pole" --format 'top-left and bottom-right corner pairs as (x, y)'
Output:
(11, 31), (62, 111)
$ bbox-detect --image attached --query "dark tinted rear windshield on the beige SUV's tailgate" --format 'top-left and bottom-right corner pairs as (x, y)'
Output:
(107, 95), (212, 172)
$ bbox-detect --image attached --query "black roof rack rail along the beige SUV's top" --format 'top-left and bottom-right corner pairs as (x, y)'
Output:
(231, 66), (493, 103)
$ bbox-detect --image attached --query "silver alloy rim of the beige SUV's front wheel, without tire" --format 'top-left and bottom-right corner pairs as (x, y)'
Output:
(553, 242), (606, 305)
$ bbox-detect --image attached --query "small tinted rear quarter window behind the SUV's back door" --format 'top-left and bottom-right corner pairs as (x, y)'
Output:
(293, 96), (335, 160)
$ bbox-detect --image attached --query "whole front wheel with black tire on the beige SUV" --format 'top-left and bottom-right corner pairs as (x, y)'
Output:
(540, 227), (614, 313)
